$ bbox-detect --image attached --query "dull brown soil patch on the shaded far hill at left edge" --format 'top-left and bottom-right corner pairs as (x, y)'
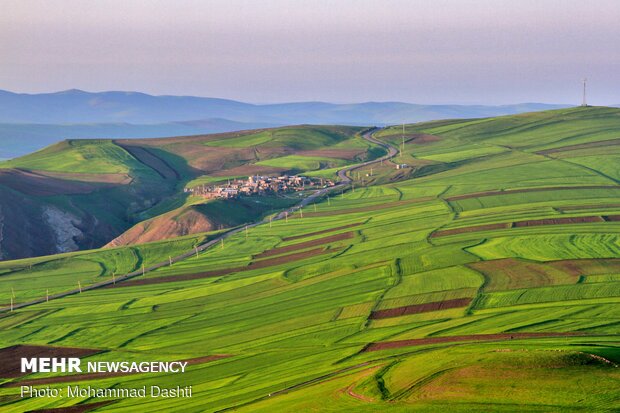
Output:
(0, 169), (100, 196)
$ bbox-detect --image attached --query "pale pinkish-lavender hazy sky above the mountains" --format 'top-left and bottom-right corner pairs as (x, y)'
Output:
(0, 0), (620, 104)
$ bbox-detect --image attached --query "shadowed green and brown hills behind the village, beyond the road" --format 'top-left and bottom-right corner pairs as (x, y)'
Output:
(0, 126), (368, 259)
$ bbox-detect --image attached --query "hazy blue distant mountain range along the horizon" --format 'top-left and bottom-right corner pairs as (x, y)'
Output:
(0, 89), (568, 158)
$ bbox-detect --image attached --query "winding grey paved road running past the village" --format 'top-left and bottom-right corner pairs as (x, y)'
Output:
(0, 128), (398, 313)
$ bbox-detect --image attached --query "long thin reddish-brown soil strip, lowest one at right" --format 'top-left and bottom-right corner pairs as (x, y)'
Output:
(362, 332), (584, 351)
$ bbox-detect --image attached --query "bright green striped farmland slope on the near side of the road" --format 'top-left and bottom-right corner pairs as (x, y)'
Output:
(0, 108), (620, 412)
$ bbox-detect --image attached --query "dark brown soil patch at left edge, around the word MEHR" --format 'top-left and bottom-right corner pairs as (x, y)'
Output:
(0, 344), (100, 379)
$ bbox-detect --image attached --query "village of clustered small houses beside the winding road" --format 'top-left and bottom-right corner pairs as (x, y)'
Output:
(185, 175), (335, 199)
